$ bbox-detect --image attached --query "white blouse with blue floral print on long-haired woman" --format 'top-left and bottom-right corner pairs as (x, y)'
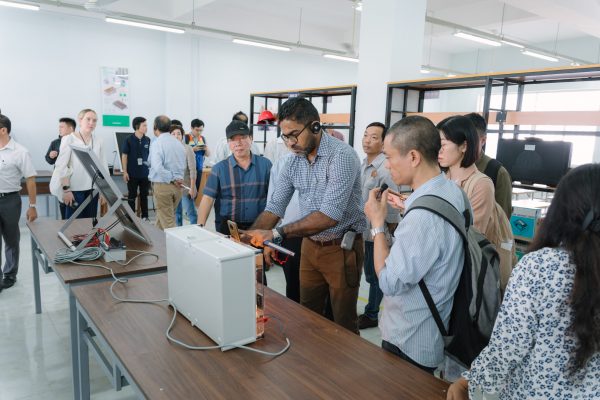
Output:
(464, 248), (600, 400)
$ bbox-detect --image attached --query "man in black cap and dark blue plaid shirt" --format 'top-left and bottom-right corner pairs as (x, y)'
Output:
(198, 120), (271, 234)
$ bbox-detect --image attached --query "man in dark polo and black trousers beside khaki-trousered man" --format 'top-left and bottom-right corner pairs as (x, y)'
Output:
(121, 117), (150, 221)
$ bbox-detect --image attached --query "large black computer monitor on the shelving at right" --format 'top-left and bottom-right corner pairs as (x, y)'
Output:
(496, 138), (573, 186)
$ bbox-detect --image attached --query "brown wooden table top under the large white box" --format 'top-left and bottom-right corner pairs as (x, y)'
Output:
(73, 274), (448, 400)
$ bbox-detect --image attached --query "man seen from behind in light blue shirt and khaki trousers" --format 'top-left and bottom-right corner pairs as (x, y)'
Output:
(148, 115), (185, 230)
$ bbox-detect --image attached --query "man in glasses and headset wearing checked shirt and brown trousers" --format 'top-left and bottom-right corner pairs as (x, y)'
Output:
(245, 97), (366, 334)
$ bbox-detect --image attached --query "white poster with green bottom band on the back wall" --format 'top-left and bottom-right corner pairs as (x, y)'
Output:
(100, 67), (130, 127)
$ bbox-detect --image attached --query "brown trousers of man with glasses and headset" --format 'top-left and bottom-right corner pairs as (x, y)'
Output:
(300, 237), (364, 334)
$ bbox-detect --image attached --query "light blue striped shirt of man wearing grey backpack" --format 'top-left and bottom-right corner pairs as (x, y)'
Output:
(379, 174), (470, 367)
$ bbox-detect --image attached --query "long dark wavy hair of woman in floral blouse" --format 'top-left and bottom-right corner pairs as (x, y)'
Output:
(529, 164), (600, 374)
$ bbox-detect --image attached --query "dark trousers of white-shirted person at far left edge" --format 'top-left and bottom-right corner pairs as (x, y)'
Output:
(0, 193), (21, 279)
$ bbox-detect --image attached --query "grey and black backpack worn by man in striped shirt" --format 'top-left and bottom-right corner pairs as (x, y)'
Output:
(404, 192), (501, 367)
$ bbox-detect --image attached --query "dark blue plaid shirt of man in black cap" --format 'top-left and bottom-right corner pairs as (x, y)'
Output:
(203, 154), (271, 226)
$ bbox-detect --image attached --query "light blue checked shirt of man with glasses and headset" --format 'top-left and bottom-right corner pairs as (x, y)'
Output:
(265, 134), (367, 240)
